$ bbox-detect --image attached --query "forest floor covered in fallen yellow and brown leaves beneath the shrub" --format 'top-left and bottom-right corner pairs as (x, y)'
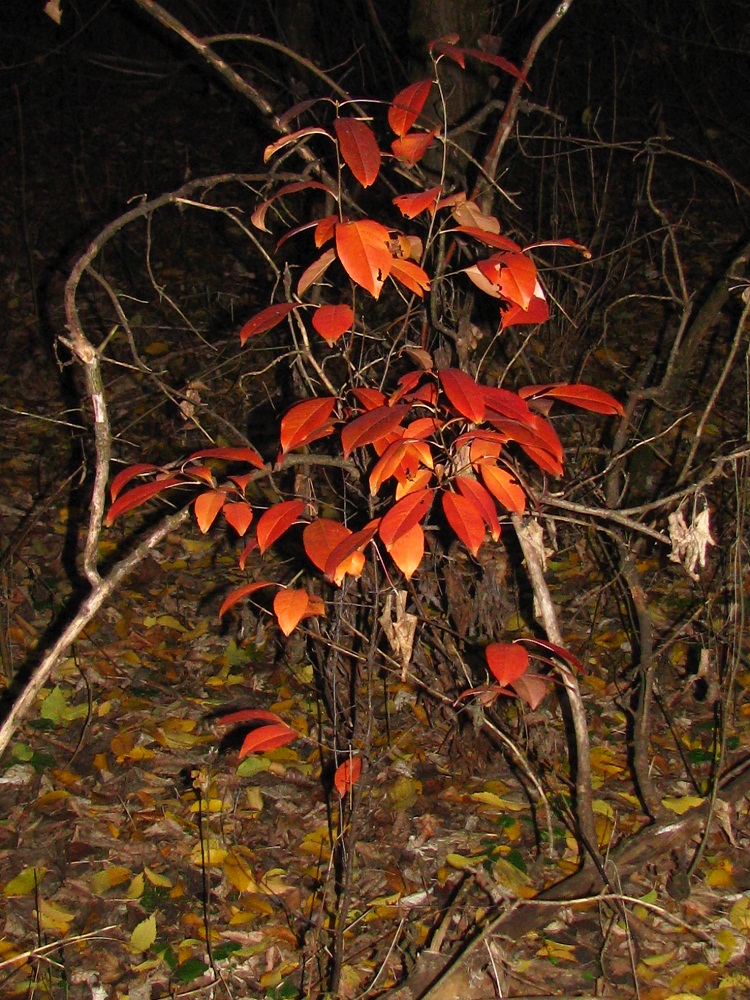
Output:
(0, 35), (750, 1000)
